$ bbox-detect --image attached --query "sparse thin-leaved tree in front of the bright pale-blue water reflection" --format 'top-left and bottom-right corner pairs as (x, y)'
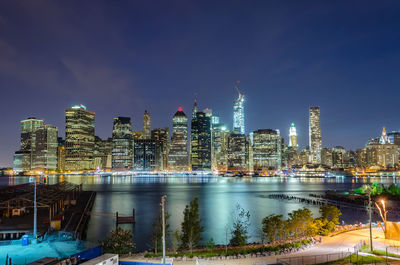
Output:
(229, 204), (250, 246)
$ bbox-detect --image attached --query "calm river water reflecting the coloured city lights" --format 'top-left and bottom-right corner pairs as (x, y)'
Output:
(0, 175), (399, 251)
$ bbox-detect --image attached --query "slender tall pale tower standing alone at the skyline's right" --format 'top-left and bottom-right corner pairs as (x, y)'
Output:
(309, 107), (322, 164)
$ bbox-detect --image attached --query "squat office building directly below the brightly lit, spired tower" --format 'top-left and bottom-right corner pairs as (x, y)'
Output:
(227, 133), (253, 171)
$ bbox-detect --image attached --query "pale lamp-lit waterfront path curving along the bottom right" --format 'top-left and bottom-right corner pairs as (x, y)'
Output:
(121, 228), (400, 265)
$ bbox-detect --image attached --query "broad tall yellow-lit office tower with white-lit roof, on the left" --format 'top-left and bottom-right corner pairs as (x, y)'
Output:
(65, 105), (95, 171)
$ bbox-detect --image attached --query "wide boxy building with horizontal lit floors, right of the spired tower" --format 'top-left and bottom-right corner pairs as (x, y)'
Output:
(253, 129), (282, 171)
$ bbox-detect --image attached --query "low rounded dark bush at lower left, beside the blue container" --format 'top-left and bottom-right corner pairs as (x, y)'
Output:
(101, 227), (136, 255)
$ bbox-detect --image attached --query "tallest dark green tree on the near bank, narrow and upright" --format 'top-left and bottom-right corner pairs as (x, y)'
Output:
(180, 197), (204, 252)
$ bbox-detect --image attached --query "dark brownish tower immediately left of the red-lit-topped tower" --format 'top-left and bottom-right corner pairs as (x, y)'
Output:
(151, 127), (169, 170)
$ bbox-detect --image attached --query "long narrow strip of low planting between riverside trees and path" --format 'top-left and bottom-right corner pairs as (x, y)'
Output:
(145, 239), (311, 258)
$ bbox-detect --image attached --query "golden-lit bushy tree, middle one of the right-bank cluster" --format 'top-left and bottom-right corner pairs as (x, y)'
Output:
(288, 208), (314, 238)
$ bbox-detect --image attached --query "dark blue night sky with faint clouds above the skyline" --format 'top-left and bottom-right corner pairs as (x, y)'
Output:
(0, 0), (400, 166)
